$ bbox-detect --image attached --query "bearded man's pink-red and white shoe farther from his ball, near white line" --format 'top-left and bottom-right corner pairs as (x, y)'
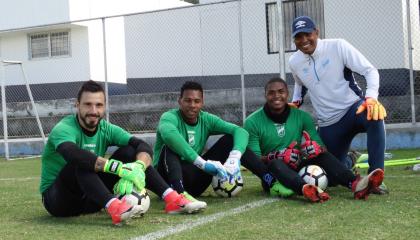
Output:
(164, 191), (207, 214)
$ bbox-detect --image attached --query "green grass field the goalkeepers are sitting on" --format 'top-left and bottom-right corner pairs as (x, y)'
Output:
(0, 149), (420, 240)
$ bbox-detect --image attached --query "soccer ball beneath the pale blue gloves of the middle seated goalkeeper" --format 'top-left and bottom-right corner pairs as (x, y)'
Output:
(211, 173), (244, 197)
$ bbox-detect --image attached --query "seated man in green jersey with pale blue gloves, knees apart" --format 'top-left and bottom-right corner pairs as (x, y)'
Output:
(153, 81), (293, 206)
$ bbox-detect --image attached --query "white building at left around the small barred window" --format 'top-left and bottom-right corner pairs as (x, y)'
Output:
(0, 0), (189, 98)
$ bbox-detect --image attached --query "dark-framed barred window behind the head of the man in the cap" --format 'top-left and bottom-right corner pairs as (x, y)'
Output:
(265, 0), (325, 54)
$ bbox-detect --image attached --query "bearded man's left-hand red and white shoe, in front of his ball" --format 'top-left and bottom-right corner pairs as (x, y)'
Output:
(107, 199), (140, 226)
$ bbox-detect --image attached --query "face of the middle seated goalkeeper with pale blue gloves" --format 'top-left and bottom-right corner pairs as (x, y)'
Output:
(178, 89), (204, 124)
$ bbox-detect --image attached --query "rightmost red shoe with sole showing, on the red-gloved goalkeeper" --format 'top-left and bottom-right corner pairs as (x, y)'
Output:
(351, 168), (384, 200)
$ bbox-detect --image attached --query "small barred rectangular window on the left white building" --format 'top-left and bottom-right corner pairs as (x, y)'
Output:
(29, 31), (70, 59)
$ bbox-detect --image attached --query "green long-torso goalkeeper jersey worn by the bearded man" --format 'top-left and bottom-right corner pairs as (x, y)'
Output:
(40, 115), (131, 193)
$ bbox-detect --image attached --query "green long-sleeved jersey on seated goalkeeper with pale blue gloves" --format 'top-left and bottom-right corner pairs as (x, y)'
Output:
(153, 109), (248, 167)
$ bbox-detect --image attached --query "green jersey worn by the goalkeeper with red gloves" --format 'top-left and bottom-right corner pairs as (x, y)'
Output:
(245, 108), (324, 157)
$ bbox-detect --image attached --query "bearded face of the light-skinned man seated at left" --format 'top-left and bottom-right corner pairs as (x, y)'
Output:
(76, 92), (105, 132)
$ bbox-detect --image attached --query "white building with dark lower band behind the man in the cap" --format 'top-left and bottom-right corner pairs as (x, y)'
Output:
(125, 0), (420, 94)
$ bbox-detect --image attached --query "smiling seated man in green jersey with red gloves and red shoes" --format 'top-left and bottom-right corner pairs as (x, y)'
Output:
(245, 78), (384, 202)
